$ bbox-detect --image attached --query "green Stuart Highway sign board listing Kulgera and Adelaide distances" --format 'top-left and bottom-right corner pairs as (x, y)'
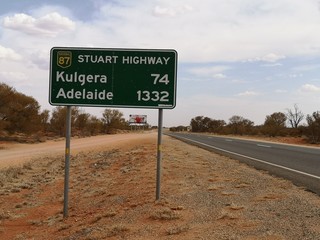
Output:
(49, 47), (177, 109)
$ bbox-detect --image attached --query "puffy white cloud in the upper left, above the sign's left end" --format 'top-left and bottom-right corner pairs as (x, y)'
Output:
(3, 12), (75, 37)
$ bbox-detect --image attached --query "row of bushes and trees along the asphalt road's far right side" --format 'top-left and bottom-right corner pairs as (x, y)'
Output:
(170, 104), (320, 144)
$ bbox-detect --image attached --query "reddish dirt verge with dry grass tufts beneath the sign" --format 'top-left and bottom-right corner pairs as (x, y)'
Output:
(0, 134), (320, 240)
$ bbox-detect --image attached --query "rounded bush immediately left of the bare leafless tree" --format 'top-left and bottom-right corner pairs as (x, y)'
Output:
(263, 112), (287, 137)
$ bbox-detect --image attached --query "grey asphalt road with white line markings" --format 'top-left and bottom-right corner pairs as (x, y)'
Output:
(167, 132), (320, 195)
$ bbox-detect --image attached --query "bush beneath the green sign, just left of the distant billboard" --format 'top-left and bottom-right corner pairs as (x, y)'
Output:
(101, 109), (127, 133)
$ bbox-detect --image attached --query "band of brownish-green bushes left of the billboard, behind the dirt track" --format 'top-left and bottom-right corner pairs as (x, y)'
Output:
(0, 83), (142, 142)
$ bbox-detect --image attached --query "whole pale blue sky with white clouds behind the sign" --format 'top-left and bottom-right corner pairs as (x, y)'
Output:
(0, 0), (320, 127)
